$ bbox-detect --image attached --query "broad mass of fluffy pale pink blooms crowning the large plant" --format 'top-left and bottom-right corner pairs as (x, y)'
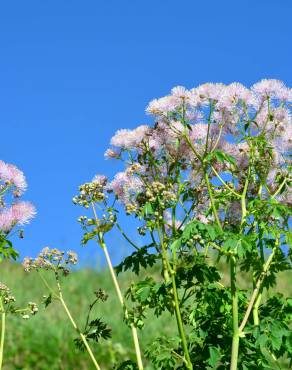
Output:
(101, 79), (292, 210)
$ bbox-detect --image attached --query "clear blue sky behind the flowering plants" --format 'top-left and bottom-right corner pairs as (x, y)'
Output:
(0, 0), (292, 263)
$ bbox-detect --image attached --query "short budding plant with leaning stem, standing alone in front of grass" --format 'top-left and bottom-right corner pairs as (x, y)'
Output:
(23, 247), (111, 370)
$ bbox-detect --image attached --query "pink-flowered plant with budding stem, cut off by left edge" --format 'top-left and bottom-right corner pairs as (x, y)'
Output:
(0, 160), (38, 369)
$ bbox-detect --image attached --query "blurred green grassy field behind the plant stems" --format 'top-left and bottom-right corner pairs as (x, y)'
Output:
(0, 263), (292, 370)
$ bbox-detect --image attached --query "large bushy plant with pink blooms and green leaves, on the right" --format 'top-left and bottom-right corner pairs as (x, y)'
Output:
(74, 80), (292, 370)
